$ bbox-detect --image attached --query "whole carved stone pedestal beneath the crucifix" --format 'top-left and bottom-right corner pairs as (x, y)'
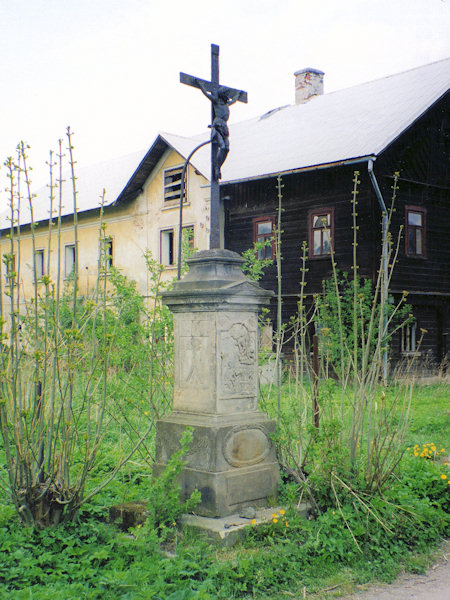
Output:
(154, 250), (279, 517)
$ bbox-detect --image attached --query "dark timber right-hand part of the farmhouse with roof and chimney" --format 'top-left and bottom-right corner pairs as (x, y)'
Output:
(222, 60), (450, 368)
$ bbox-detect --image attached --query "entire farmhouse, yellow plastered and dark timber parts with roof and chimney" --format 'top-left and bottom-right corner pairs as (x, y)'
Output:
(0, 59), (450, 366)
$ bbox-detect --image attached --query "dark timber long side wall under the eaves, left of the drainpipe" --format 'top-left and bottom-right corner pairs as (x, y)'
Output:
(224, 165), (381, 295)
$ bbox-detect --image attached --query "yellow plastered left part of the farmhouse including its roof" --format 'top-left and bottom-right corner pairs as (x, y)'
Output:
(0, 134), (209, 304)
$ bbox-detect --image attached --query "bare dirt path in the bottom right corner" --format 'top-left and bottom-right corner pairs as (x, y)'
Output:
(340, 540), (450, 600)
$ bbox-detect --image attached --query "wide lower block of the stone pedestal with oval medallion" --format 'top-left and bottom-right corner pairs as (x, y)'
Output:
(153, 411), (279, 517)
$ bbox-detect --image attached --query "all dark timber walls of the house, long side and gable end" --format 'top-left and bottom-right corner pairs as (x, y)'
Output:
(222, 95), (450, 370)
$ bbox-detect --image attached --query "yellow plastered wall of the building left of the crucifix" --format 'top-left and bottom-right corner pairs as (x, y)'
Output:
(0, 150), (209, 324)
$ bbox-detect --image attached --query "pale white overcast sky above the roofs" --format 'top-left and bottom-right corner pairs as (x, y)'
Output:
(0, 0), (450, 192)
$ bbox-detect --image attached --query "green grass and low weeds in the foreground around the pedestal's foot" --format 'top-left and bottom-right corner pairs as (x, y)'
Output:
(0, 385), (450, 600)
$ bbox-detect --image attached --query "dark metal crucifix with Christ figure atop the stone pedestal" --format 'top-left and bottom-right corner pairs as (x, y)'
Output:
(180, 44), (247, 248)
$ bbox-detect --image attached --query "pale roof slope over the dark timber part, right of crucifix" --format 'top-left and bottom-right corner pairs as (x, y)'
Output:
(195, 59), (450, 183)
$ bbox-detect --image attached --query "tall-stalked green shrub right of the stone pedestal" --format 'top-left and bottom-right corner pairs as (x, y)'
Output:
(266, 172), (411, 507)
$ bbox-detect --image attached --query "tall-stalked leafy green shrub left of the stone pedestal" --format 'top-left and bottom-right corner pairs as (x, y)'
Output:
(0, 129), (172, 527)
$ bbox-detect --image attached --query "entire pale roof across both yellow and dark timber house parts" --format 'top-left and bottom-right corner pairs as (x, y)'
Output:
(0, 59), (450, 228)
